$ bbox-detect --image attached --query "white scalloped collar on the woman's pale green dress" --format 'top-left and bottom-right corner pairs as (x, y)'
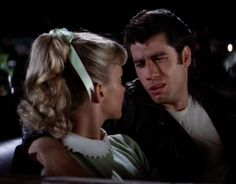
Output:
(62, 129), (111, 158)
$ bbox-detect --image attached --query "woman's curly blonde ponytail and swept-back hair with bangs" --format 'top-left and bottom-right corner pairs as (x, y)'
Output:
(17, 32), (127, 138)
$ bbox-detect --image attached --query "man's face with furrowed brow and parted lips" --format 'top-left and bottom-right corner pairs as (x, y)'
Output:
(130, 34), (190, 108)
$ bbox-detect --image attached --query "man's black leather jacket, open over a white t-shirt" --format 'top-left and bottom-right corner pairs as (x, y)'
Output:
(105, 79), (236, 182)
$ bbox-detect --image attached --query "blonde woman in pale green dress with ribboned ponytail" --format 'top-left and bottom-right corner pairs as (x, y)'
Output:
(18, 29), (153, 180)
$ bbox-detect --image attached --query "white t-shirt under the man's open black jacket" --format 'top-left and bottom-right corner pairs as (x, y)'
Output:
(169, 96), (228, 182)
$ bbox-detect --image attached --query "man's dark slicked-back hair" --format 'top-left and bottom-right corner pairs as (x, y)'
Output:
(122, 9), (192, 54)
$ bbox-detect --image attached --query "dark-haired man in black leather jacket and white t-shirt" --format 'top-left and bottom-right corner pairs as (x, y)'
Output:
(107, 9), (236, 182)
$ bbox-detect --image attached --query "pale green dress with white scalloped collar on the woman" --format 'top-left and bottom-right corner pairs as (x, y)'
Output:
(63, 129), (150, 180)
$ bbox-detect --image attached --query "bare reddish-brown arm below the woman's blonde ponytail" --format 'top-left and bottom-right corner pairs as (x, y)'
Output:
(28, 137), (87, 177)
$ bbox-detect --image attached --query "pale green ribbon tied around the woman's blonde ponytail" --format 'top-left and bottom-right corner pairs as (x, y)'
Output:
(49, 28), (94, 100)
